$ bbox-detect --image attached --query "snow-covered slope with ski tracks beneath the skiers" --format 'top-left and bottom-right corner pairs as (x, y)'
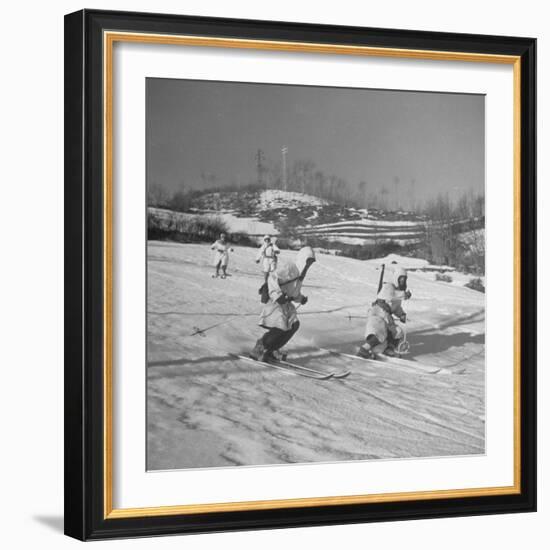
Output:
(147, 241), (485, 470)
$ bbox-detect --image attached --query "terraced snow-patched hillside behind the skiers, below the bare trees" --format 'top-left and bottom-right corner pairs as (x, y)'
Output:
(153, 187), (485, 276)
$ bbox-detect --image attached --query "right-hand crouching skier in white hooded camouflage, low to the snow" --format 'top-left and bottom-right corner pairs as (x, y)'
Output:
(357, 268), (411, 359)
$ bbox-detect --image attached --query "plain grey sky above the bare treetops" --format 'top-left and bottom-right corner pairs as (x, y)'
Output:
(146, 78), (485, 205)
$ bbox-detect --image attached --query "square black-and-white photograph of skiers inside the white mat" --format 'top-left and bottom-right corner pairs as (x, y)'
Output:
(146, 78), (486, 471)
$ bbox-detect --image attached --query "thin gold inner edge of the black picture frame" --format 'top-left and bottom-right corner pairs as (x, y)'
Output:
(103, 31), (521, 519)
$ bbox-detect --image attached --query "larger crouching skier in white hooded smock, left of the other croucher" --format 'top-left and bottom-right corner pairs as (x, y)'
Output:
(250, 246), (315, 361)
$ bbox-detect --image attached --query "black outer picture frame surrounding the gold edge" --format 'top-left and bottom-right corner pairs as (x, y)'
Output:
(65, 10), (537, 540)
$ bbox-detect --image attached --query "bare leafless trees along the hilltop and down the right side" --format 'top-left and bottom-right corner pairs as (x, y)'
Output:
(147, 151), (485, 273)
